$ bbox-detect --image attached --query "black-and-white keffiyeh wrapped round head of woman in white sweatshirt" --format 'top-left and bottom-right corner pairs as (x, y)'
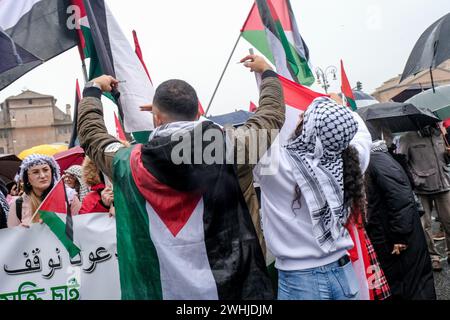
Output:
(285, 97), (358, 252)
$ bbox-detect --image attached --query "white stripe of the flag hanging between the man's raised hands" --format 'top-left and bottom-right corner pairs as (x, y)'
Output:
(105, 5), (155, 132)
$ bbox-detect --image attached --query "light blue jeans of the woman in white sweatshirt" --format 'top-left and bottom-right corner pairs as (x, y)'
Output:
(278, 261), (359, 300)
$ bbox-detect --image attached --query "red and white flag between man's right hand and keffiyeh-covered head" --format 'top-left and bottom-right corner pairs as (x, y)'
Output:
(278, 76), (327, 143)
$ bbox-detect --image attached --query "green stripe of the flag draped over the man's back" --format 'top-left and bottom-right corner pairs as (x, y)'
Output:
(113, 148), (163, 300)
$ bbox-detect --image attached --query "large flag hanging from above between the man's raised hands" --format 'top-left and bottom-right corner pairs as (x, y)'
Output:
(73, 0), (154, 132)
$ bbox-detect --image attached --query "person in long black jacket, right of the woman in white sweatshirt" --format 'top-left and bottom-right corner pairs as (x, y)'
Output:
(366, 124), (436, 300)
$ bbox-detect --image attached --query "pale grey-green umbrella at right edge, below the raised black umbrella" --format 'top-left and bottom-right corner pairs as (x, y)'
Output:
(406, 85), (450, 120)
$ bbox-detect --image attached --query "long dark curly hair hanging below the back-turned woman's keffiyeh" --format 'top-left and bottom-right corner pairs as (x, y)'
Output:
(292, 121), (366, 223)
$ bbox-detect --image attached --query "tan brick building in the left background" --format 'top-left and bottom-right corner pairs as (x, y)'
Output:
(0, 90), (72, 154)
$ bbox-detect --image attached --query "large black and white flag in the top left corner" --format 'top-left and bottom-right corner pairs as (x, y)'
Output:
(0, 0), (77, 90)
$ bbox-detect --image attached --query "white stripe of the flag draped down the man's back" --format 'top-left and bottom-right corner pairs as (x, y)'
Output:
(146, 199), (218, 300)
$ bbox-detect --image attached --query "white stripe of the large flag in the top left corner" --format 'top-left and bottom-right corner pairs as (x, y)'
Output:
(0, 0), (42, 30)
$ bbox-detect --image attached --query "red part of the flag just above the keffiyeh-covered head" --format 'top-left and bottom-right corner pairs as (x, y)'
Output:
(278, 75), (328, 111)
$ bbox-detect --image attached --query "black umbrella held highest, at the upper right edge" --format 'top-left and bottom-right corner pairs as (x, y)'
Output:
(400, 13), (450, 89)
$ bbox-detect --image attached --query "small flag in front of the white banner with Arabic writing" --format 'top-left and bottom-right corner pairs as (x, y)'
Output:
(38, 179), (81, 258)
